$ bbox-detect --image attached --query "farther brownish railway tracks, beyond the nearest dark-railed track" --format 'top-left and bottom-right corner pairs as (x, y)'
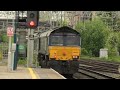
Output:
(79, 60), (120, 74)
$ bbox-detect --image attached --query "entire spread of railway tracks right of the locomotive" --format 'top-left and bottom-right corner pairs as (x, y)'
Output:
(73, 60), (120, 79)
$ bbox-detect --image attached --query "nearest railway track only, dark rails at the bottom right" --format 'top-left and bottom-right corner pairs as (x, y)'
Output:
(73, 68), (120, 79)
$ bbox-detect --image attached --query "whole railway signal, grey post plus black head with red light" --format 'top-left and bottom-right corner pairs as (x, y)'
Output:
(27, 11), (39, 67)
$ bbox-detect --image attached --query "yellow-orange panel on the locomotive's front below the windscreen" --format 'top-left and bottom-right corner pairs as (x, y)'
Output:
(49, 46), (80, 60)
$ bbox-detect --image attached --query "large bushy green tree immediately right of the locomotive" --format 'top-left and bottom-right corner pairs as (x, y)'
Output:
(76, 18), (109, 56)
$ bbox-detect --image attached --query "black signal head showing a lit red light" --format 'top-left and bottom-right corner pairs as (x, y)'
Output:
(27, 11), (39, 28)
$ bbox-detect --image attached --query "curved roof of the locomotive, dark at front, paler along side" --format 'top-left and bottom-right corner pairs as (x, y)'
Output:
(40, 26), (79, 37)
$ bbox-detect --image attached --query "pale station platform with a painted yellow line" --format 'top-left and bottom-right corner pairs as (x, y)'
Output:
(0, 66), (66, 79)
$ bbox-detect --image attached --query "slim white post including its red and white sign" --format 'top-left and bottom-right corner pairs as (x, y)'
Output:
(7, 27), (14, 71)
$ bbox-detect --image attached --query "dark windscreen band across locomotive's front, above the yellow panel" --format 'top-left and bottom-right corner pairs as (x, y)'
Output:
(49, 33), (80, 46)
